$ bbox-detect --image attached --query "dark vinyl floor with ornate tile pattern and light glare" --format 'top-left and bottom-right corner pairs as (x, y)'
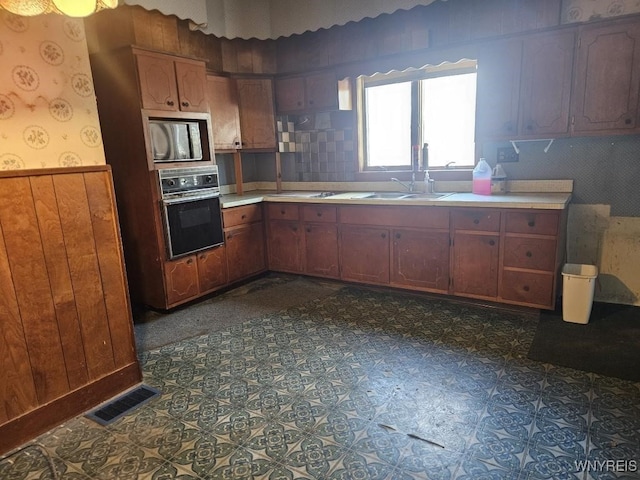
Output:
(0, 287), (640, 480)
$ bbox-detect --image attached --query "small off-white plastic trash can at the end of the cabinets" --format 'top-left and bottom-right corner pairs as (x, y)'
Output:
(562, 263), (598, 323)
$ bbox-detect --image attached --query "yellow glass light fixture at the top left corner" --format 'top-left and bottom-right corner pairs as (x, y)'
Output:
(0, 0), (118, 17)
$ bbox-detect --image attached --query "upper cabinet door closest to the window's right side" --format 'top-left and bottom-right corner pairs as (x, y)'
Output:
(476, 40), (522, 139)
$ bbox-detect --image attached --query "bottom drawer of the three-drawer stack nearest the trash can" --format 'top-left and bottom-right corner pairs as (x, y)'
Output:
(501, 270), (553, 307)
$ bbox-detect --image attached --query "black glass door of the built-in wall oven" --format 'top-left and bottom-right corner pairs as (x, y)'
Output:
(162, 196), (224, 258)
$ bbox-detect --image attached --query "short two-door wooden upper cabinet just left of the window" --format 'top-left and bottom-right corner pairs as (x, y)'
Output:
(275, 72), (350, 113)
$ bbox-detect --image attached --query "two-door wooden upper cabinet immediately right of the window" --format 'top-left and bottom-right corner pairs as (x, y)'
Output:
(477, 29), (575, 140)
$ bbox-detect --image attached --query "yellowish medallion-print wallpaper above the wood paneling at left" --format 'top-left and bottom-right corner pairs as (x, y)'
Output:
(0, 11), (105, 170)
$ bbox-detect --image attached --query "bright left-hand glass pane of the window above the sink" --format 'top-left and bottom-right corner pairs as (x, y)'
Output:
(365, 82), (411, 167)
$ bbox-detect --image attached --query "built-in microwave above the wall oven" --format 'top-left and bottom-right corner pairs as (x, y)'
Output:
(149, 119), (202, 162)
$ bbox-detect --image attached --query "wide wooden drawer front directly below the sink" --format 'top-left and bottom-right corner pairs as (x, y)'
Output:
(340, 205), (449, 229)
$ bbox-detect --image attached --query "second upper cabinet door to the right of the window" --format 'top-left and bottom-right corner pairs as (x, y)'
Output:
(518, 30), (575, 137)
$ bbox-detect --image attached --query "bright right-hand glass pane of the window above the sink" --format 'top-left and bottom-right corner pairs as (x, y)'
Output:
(420, 73), (476, 167)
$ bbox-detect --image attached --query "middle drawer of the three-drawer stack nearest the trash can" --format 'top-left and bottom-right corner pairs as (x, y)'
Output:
(504, 237), (556, 272)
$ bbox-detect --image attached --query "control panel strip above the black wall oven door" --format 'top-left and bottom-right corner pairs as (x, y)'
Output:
(158, 165), (220, 198)
